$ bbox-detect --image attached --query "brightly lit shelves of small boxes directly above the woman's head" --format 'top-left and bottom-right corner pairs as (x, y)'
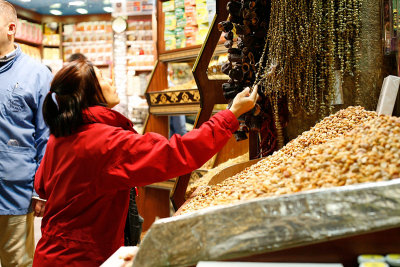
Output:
(62, 21), (113, 65)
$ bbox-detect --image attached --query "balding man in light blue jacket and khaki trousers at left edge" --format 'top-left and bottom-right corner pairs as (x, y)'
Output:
(0, 0), (52, 267)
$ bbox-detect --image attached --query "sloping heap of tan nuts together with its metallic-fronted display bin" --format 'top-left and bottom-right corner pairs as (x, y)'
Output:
(134, 107), (400, 266)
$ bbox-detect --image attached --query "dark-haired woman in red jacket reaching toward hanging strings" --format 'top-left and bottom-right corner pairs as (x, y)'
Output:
(33, 60), (257, 267)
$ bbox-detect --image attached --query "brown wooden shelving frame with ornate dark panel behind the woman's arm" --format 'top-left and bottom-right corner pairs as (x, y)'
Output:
(137, 0), (249, 231)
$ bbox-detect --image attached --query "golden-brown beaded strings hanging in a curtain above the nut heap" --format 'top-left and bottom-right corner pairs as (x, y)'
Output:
(260, 0), (362, 123)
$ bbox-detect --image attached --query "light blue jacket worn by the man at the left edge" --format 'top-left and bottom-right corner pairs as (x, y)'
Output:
(0, 46), (52, 215)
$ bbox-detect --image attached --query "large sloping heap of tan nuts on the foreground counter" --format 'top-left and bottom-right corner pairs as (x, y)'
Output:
(181, 107), (400, 214)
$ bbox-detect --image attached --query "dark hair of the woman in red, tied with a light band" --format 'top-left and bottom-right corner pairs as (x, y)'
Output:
(43, 59), (106, 137)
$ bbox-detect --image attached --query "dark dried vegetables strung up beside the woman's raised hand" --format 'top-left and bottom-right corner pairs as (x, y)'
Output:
(218, 0), (269, 141)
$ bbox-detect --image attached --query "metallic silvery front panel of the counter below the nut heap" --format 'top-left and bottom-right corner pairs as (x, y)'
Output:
(133, 179), (400, 266)
